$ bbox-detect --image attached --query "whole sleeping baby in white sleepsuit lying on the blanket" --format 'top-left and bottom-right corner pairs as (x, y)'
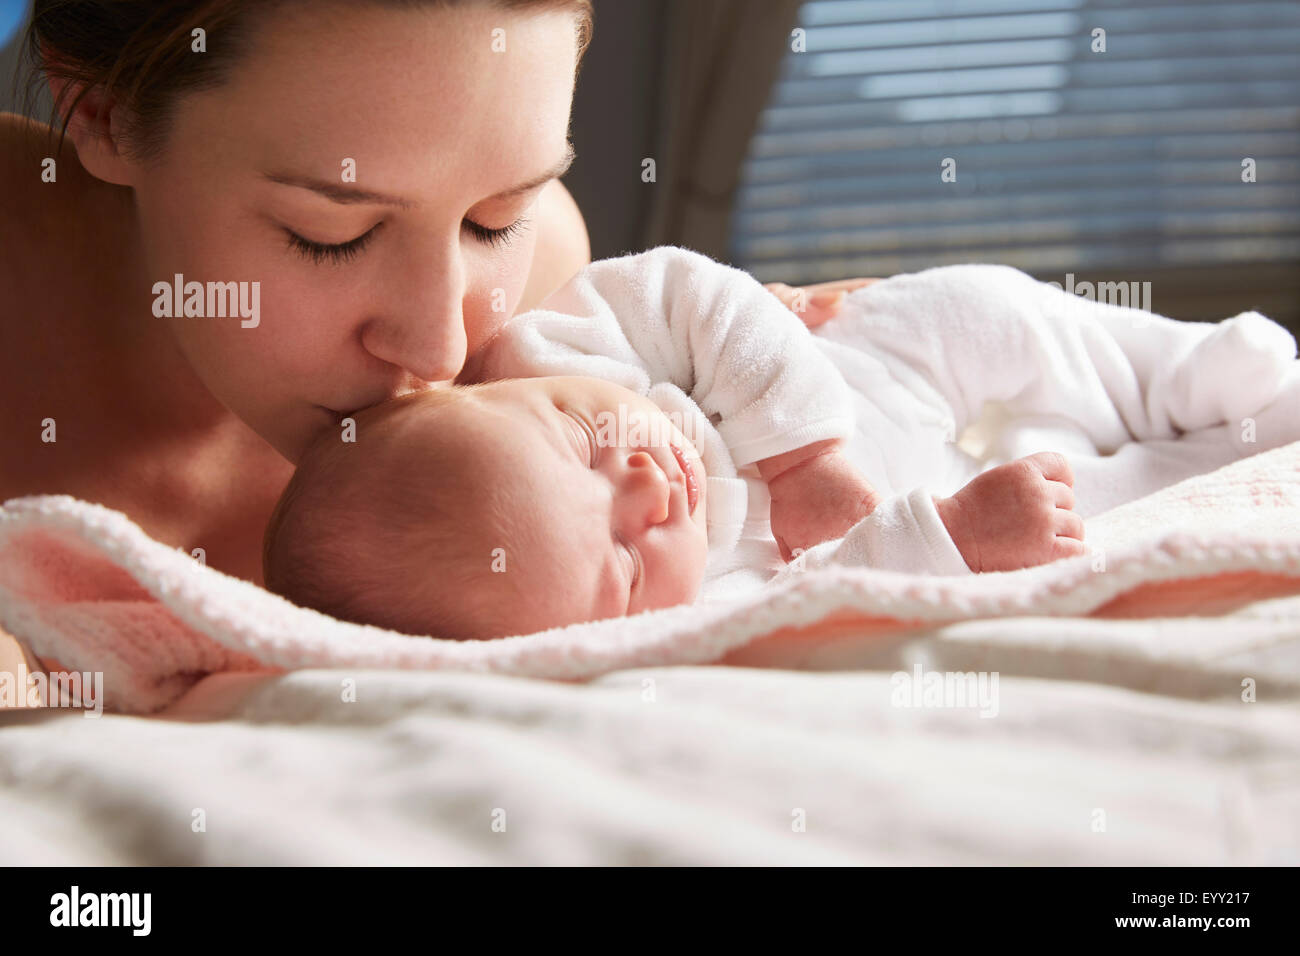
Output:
(264, 247), (1300, 639)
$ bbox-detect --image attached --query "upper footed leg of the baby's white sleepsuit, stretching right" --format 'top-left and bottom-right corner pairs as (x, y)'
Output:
(850, 265), (1296, 451)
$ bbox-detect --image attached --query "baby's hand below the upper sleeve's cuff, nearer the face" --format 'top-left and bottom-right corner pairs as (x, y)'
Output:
(758, 441), (880, 561)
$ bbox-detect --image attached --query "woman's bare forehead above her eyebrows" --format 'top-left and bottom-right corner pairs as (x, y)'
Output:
(182, 4), (575, 200)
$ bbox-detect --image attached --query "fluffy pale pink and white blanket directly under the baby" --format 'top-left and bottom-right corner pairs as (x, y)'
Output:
(0, 442), (1300, 713)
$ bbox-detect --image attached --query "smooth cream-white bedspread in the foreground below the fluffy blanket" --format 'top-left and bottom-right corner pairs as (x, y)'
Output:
(0, 597), (1300, 865)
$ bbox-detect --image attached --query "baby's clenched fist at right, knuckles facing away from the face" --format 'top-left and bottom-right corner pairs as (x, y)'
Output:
(935, 451), (1084, 571)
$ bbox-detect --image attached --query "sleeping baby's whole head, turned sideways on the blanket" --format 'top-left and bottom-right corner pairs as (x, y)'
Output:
(263, 377), (709, 639)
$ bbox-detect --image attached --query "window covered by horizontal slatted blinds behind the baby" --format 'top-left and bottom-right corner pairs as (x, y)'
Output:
(732, 0), (1300, 320)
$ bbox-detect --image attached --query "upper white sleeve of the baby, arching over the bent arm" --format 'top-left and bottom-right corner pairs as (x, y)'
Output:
(477, 246), (853, 468)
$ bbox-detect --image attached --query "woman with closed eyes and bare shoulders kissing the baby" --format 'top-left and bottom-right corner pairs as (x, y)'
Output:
(0, 0), (873, 581)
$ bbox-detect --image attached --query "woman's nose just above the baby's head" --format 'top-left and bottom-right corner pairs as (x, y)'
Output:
(361, 238), (468, 382)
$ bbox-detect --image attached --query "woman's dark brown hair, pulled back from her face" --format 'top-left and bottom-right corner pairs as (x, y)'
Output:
(25, 0), (593, 159)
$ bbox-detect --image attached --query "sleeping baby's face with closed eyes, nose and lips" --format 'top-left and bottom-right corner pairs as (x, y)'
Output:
(413, 377), (709, 633)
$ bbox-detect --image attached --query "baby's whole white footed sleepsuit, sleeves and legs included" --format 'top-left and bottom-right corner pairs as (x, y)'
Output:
(478, 246), (1300, 600)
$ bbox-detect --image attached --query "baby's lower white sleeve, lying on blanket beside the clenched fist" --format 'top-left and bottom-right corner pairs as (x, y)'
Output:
(777, 488), (972, 579)
